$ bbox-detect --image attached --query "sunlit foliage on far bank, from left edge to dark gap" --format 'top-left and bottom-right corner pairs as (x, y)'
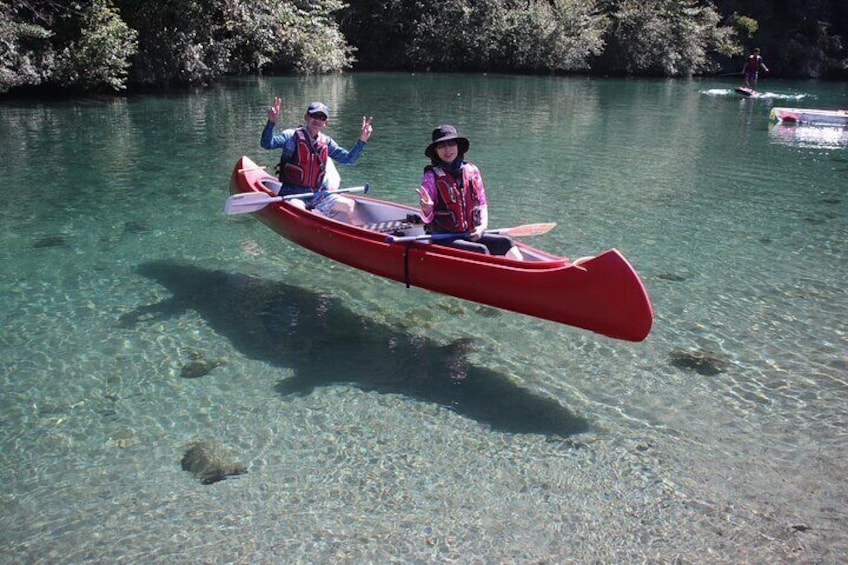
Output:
(0, 0), (354, 91)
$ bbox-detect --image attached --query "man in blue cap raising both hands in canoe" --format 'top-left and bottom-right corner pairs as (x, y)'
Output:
(259, 97), (373, 218)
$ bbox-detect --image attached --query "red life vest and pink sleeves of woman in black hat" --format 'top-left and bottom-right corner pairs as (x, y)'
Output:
(425, 163), (483, 233)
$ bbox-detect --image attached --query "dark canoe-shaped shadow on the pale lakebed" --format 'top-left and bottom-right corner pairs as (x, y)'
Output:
(126, 261), (588, 436)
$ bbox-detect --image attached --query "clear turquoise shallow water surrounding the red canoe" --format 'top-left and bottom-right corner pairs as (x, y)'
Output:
(0, 74), (848, 563)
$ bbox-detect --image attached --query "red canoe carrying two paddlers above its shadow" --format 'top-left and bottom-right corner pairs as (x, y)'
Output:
(228, 157), (653, 341)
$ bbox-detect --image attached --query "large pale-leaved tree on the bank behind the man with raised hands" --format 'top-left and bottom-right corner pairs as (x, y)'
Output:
(118, 0), (353, 85)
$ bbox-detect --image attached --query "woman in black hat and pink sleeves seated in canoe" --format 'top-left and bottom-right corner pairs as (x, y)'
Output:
(417, 125), (522, 260)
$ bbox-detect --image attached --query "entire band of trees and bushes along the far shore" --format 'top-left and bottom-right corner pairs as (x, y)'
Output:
(0, 0), (848, 98)
